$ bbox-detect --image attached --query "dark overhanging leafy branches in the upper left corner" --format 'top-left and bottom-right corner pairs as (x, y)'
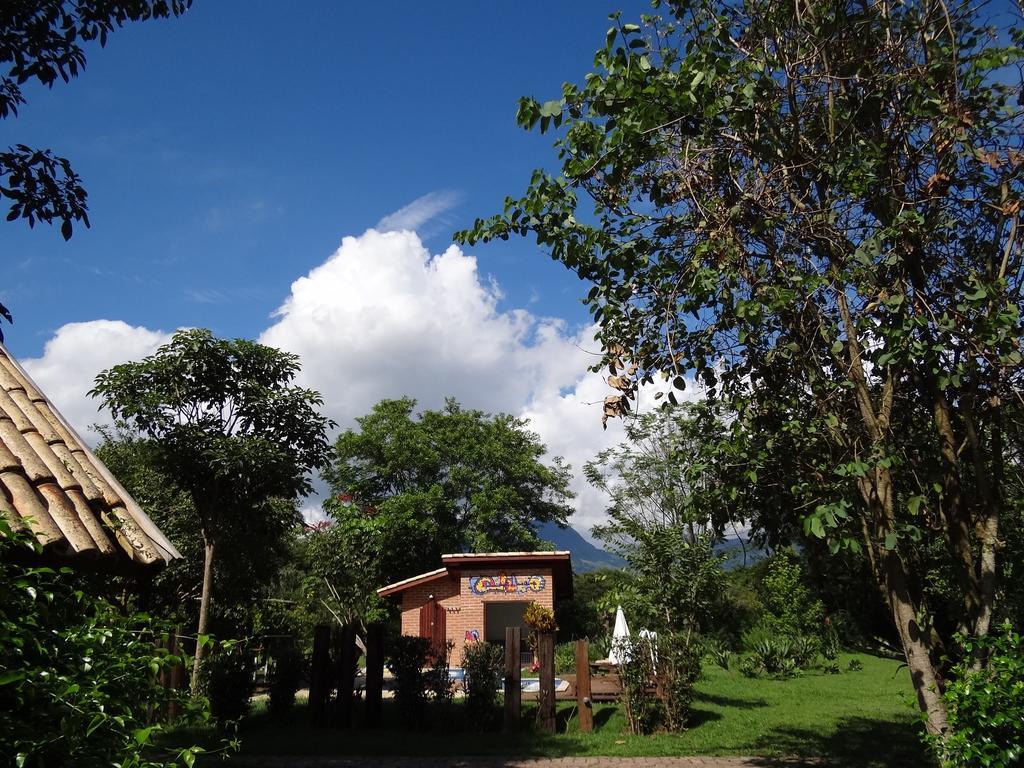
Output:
(0, 0), (191, 339)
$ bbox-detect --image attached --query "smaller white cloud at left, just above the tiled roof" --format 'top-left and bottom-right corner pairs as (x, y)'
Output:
(20, 319), (170, 441)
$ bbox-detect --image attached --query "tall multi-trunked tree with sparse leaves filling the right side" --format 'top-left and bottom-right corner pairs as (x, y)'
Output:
(462, 0), (1024, 732)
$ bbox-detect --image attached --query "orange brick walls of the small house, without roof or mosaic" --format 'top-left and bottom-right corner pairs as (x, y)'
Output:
(401, 565), (555, 667)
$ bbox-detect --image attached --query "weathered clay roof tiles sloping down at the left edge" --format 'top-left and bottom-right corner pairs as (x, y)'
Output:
(0, 344), (181, 569)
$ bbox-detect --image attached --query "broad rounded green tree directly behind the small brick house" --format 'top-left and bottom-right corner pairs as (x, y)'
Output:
(324, 398), (572, 598)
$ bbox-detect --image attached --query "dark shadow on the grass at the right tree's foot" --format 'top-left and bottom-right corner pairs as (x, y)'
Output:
(755, 717), (932, 768)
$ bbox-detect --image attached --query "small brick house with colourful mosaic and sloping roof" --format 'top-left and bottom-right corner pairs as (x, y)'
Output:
(377, 552), (572, 667)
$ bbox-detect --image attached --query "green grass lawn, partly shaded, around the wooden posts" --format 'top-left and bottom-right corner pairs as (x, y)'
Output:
(184, 655), (927, 768)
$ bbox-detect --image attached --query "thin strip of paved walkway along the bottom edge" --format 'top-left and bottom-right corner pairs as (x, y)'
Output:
(231, 756), (826, 768)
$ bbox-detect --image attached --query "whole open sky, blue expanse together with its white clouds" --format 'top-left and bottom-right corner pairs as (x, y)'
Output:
(0, 0), (649, 529)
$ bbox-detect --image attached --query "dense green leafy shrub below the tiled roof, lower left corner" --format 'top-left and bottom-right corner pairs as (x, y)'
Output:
(0, 518), (207, 768)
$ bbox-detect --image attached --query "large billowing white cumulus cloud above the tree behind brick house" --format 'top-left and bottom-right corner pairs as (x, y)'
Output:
(260, 229), (586, 425)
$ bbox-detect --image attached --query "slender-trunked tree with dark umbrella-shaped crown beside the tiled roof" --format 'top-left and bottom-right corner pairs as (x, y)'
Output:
(91, 329), (330, 688)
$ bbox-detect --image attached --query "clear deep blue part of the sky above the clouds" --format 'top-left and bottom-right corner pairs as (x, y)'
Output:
(0, 0), (645, 355)
